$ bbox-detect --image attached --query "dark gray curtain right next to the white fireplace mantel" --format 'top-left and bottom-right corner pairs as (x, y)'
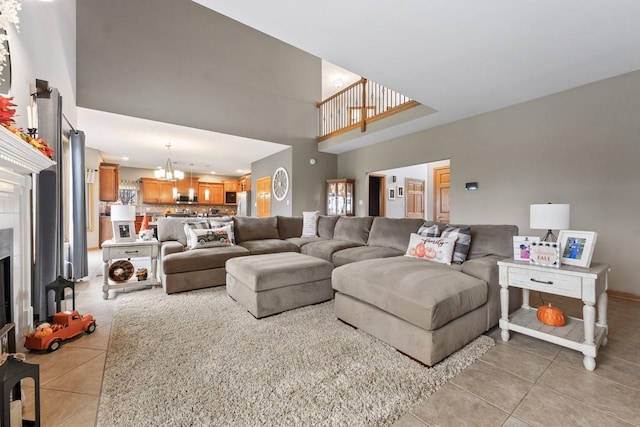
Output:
(31, 89), (64, 319)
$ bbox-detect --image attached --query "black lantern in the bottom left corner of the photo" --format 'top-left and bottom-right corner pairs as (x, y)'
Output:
(0, 356), (40, 427)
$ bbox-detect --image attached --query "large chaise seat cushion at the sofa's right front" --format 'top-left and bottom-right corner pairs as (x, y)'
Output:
(331, 257), (488, 331)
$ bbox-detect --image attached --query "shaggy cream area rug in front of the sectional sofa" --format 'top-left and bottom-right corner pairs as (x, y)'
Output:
(98, 287), (495, 426)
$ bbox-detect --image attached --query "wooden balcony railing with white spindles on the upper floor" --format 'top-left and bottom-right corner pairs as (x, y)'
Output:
(317, 78), (419, 142)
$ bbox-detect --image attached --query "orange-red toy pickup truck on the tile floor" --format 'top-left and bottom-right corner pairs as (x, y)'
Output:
(24, 310), (96, 351)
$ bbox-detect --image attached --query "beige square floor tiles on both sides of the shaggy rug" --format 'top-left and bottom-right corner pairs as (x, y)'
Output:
(12, 250), (640, 427)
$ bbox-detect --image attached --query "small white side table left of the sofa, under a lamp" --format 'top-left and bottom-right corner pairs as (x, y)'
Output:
(102, 239), (160, 299)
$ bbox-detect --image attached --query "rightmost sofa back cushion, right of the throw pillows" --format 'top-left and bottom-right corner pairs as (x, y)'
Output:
(467, 224), (518, 259)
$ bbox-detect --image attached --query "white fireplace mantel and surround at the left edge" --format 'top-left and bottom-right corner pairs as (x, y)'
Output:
(0, 126), (55, 336)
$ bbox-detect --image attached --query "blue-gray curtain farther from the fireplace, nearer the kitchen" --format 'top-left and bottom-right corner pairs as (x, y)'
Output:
(69, 131), (89, 280)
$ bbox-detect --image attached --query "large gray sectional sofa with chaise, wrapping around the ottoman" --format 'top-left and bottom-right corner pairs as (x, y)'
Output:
(158, 216), (520, 366)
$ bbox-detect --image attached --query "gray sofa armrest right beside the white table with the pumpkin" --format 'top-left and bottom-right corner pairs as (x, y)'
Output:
(462, 255), (522, 330)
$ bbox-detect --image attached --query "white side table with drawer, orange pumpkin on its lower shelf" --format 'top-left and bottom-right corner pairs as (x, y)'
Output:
(498, 259), (609, 371)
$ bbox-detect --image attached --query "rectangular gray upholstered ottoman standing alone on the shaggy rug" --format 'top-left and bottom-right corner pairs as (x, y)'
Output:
(225, 252), (333, 319)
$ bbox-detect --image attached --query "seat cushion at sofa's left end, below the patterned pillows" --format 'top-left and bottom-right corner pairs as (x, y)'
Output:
(162, 246), (249, 274)
